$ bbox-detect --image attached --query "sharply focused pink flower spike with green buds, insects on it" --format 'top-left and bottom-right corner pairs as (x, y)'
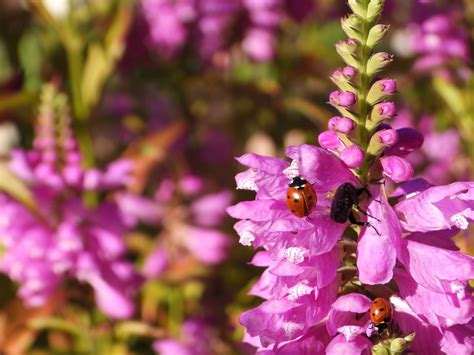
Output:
(228, 0), (474, 354)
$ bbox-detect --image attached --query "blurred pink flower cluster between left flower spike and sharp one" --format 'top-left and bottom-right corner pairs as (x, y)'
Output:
(115, 174), (232, 279)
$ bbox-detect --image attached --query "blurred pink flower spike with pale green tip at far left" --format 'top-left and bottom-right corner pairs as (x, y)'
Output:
(0, 85), (140, 318)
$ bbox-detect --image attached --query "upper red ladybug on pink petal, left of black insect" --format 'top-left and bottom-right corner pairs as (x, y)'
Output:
(286, 176), (317, 218)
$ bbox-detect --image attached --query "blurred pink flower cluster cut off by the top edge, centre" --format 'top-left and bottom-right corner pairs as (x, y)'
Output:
(142, 0), (311, 61)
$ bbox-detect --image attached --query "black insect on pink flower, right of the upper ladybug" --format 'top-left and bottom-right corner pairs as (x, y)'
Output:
(331, 182), (380, 235)
